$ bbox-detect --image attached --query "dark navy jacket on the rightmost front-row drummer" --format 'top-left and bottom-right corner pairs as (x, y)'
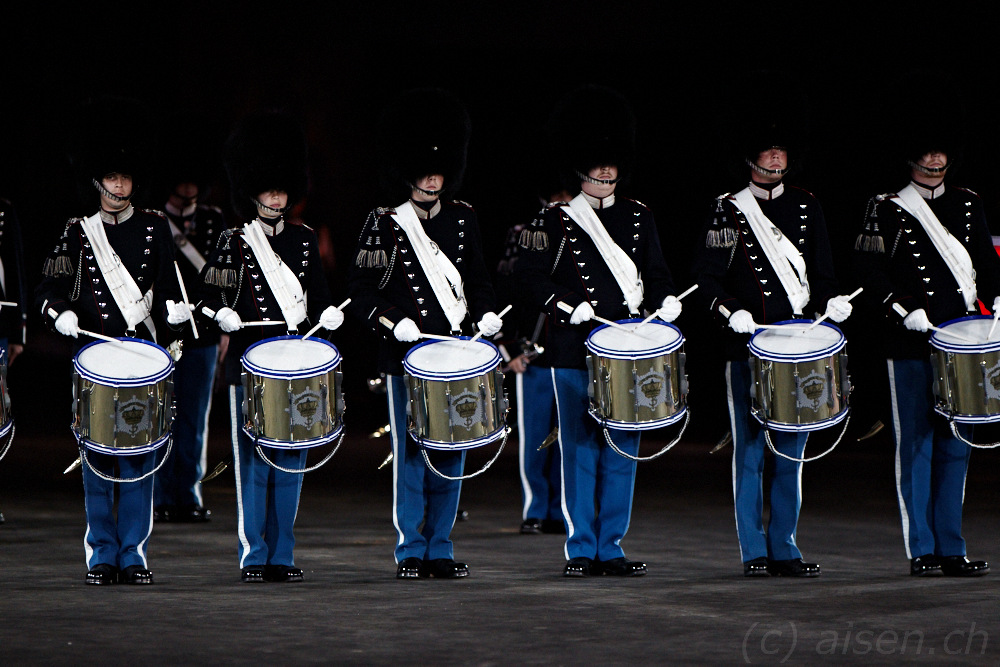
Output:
(854, 183), (1000, 359)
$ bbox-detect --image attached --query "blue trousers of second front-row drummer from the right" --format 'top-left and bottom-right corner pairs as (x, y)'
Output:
(726, 361), (808, 563)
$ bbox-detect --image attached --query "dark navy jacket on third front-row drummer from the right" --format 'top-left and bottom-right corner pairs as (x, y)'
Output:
(514, 192), (675, 369)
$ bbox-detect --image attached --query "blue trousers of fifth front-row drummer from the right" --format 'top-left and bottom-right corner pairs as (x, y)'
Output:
(229, 385), (307, 568)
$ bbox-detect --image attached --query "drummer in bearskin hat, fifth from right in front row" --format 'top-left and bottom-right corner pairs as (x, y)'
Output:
(198, 112), (344, 583)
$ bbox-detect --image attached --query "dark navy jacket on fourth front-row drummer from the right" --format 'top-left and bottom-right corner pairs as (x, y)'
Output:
(348, 201), (496, 375)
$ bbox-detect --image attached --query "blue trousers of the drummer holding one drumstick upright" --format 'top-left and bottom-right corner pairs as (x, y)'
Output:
(83, 449), (156, 569)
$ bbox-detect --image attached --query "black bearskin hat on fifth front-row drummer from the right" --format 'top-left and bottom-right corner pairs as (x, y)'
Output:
(223, 111), (309, 220)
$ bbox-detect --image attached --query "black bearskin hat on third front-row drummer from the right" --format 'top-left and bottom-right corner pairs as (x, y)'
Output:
(546, 84), (635, 192)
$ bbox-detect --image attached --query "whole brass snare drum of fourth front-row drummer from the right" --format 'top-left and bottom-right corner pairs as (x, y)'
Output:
(403, 337), (508, 450)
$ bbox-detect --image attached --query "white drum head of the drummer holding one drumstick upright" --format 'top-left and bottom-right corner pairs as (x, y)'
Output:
(73, 339), (174, 387)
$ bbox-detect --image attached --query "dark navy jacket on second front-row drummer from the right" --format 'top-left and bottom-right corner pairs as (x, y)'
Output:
(691, 183), (839, 361)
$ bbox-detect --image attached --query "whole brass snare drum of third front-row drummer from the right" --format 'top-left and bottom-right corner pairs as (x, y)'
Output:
(587, 320), (688, 431)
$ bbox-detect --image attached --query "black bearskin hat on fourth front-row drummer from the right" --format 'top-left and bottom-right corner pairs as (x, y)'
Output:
(376, 88), (472, 204)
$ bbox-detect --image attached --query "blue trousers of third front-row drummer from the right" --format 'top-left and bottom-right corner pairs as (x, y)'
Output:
(550, 368), (639, 561)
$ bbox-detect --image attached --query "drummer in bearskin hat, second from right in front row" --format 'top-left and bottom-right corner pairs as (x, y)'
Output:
(693, 78), (851, 577)
